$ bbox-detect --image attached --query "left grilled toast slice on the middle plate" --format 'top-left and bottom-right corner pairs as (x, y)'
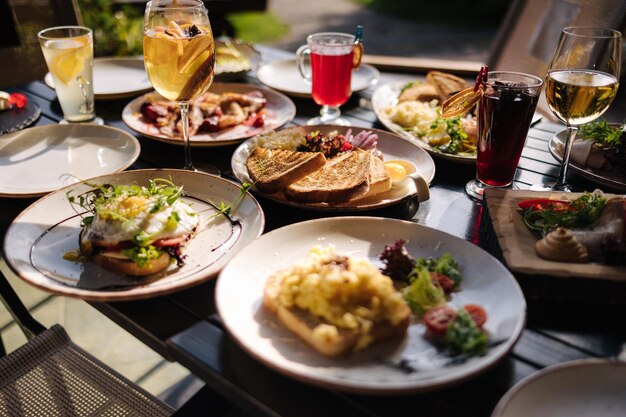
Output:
(246, 147), (326, 193)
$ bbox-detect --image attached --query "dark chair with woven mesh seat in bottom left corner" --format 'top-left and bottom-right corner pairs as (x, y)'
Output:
(0, 272), (174, 416)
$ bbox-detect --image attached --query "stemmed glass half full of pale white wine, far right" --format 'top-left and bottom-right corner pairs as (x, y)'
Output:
(533, 27), (622, 191)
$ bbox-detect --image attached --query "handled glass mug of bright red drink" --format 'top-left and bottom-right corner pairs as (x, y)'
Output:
(297, 32), (363, 126)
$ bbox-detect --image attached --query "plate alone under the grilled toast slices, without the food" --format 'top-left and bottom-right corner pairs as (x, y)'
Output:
(231, 125), (435, 211)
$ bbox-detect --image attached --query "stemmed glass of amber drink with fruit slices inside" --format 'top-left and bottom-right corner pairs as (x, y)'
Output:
(143, 0), (215, 171)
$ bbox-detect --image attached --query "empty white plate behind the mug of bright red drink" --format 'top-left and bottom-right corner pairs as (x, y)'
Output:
(256, 59), (380, 97)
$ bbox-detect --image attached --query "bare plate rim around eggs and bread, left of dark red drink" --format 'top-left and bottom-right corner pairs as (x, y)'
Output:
(372, 81), (476, 164)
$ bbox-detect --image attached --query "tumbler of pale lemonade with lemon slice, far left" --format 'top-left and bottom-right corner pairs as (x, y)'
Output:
(37, 26), (96, 122)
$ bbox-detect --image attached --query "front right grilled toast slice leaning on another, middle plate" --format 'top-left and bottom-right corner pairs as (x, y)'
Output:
(285, 149), (371, 203)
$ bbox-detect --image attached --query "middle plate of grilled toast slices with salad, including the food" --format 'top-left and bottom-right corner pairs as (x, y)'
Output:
(231, 125), (435, 211)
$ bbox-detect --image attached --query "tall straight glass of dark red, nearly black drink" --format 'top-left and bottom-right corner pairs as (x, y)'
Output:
(465, 71), (543, 200)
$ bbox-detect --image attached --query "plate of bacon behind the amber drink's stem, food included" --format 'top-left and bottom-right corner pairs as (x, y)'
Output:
(122, 83), (296, 147)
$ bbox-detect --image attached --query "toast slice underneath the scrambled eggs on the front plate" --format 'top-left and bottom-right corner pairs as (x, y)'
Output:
(263, 275), (411, 357)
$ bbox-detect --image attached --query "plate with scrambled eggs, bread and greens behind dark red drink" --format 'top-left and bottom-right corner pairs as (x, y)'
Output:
(372, 71), (477, 164)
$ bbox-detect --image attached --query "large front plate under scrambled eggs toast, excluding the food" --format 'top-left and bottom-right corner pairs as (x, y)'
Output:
(215, 217), (526, 394)
